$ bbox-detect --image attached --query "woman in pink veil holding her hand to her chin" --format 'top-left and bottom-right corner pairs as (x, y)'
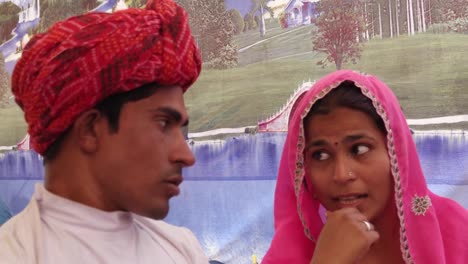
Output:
(262, 71), (468, 264)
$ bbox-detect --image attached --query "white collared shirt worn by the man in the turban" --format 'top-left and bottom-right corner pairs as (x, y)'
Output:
(0, 184), (208, 264)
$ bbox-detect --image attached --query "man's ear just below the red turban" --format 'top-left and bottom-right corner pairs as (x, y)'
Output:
(74, 109), (108, 153)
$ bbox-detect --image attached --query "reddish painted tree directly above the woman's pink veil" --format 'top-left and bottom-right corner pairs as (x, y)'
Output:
(313, 0), (364, 70)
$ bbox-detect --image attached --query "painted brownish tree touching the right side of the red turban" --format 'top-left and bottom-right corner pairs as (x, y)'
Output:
(176, 0), (237, 69)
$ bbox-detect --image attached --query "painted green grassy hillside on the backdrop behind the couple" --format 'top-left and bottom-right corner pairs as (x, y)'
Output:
(0, 31), (468, 145)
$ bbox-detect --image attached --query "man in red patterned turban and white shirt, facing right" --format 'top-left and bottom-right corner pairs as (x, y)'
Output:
(0, 0), (208, 264)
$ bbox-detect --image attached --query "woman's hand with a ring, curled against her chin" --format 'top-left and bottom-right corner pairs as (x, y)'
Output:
(310, 208), (379, 264)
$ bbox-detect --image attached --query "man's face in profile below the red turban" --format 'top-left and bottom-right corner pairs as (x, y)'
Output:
(93, 86), (195, 219)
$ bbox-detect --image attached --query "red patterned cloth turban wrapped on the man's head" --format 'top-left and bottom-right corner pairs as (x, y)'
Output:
(12, 0), (201, 154)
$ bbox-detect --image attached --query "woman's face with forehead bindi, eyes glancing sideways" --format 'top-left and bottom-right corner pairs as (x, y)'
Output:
(304, 107), (393, 221)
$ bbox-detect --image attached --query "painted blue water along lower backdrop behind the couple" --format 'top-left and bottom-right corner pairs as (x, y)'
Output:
(0, 133), (468, 263)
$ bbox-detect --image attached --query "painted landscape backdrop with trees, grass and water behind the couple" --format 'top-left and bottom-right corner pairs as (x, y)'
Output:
(0, 0), (468, 263)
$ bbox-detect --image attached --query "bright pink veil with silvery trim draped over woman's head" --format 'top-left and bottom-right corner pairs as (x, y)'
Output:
(262, 70), (468, 264)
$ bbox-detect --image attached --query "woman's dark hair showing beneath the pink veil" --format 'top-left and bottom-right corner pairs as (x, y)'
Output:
(304, 81), (387, 135)
